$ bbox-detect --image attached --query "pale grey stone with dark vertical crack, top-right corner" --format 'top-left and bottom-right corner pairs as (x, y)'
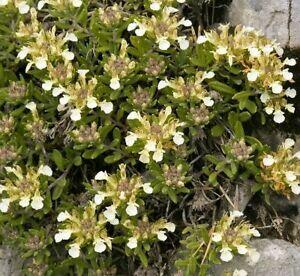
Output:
(228, 0), (300, 48)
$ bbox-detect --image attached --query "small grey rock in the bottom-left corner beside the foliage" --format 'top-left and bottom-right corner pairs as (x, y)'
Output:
(0, 247), (21, 276)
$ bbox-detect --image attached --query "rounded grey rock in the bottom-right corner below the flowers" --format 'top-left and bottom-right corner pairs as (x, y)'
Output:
(210, 239), (300, 276)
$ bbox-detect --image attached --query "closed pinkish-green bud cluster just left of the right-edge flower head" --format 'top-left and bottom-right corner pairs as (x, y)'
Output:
(225, 139), (253, 161)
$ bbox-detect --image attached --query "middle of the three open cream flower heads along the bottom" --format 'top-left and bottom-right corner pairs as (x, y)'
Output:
(124, 216), (175, 249)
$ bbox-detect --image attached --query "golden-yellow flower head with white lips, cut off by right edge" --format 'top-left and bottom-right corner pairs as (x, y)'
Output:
(260, 138), (300, 197)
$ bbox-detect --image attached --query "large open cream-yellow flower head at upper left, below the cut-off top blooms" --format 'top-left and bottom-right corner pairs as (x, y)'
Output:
(17, 22), (78, 72)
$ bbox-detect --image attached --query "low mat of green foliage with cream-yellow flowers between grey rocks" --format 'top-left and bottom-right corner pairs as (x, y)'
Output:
(0, 0), (300, 275)
